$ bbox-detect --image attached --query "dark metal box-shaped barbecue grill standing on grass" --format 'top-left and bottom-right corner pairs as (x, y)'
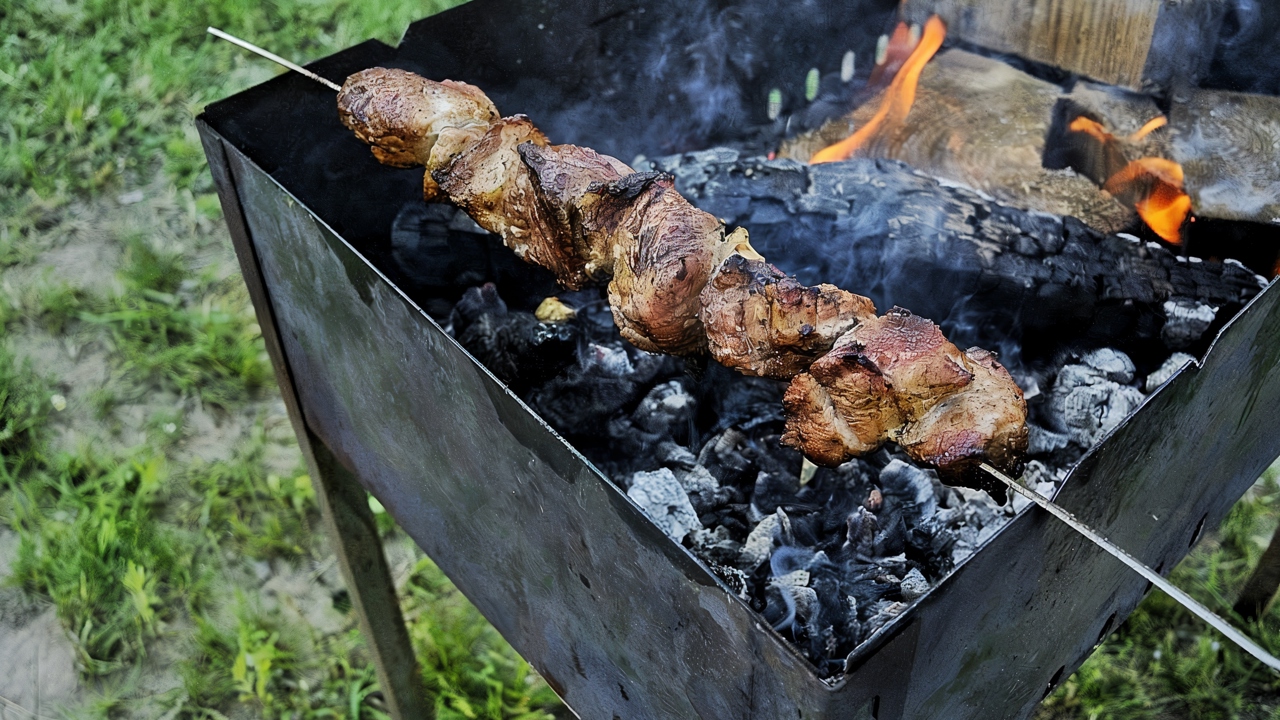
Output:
(197, 0), (1280, 720)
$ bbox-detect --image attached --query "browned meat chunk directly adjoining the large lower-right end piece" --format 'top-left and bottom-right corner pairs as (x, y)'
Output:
(701, 246), (876, 380)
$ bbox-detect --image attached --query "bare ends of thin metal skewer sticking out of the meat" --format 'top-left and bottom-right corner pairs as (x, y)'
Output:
(207, 20), (1280, 673)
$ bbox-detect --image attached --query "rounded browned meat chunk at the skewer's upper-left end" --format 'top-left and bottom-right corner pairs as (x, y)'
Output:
(338, 68), (498, 168)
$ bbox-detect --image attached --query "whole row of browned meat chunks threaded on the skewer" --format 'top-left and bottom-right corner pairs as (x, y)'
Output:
(338, 68), (1027, 489)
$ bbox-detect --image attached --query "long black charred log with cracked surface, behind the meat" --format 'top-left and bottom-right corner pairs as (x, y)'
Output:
(654, 149), (1265, 366)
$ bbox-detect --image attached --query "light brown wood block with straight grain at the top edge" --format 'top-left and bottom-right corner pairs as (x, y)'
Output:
(904, 0), (1225, 90)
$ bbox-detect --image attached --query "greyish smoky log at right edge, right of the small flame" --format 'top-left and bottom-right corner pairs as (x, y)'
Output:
(1170, 90), (1280, 225)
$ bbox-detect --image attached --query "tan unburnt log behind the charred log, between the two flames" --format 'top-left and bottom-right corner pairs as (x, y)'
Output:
(778, 50), (1136, 232)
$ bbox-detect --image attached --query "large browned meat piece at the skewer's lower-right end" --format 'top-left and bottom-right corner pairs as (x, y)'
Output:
(782, 307), (1027, 479)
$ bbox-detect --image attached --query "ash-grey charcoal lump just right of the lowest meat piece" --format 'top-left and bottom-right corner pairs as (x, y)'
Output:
(1050, 353), (1144, 448)
